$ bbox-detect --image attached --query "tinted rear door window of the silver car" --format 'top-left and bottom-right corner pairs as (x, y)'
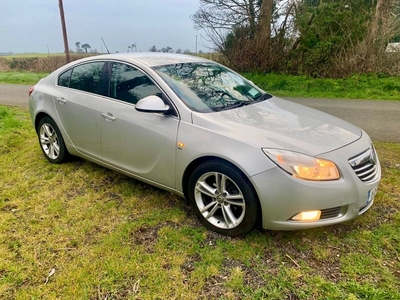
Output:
(69, 62), (104, 94)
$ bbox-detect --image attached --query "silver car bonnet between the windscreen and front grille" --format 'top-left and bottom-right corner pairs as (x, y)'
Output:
(192, 97), (362, 156)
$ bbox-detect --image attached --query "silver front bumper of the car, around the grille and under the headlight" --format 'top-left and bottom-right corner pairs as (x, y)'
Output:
(251, 133), (381, 230)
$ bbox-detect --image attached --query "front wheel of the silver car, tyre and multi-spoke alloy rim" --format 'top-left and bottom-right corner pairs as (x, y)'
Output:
(188, 160), (260, 237)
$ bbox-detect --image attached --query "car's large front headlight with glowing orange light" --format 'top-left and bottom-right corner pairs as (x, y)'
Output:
(262, 149), (340, 180)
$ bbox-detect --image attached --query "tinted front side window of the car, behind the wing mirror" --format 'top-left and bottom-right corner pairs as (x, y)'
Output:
(109, 63), (162, 104)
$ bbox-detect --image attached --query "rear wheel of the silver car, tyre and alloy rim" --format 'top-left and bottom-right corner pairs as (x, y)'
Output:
(37, 117), (69, 164)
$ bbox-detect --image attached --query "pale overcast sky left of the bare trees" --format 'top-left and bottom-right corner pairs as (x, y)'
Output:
(0, 0), (210, 53)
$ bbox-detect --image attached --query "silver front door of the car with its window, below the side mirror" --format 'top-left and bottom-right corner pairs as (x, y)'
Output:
(99, 62), (179, 187)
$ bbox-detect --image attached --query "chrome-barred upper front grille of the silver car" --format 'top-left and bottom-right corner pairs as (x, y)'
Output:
(349, 145), (378, 183)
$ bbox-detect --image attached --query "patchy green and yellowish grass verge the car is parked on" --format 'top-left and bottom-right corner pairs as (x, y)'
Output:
(0, 106), (400, 299)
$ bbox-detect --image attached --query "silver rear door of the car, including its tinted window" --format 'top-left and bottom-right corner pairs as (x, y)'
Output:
(54, 62), (104, 160)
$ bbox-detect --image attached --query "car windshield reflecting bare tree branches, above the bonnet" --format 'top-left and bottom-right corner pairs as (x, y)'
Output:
(153, 62), (271, 112)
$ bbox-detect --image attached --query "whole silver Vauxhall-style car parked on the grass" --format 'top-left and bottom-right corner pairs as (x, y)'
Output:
(29, 53), (381, 236)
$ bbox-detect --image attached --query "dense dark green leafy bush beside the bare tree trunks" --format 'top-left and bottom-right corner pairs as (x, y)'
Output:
(291, 0), (371, 76)
